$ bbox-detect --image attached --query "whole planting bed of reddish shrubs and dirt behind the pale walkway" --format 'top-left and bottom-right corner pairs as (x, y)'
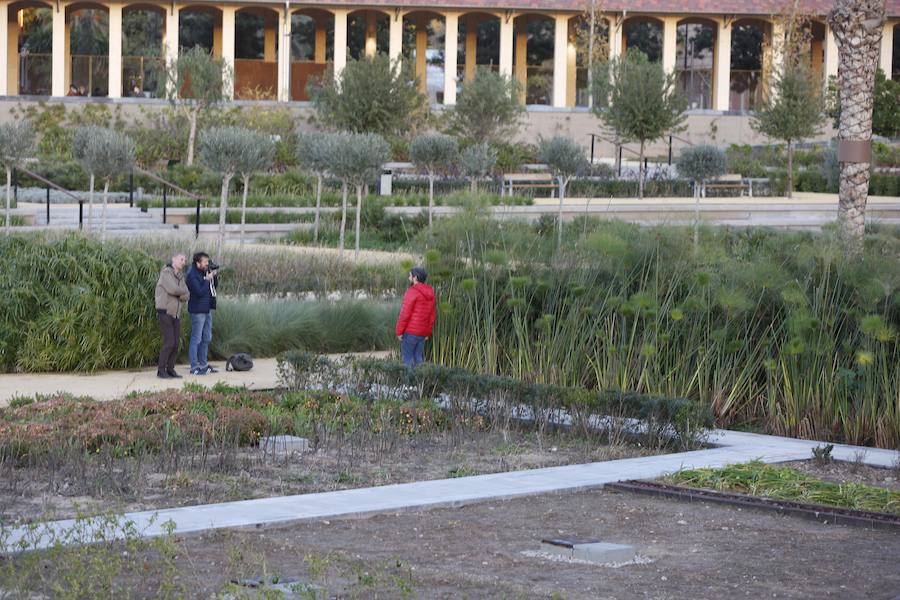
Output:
(0, 387), (660, 522)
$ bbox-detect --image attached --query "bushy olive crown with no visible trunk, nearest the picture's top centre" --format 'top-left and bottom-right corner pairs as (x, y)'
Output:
(449, 67), (525, 143)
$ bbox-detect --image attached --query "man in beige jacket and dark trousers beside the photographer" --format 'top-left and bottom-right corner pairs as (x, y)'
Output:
(156, 254), (189, 379)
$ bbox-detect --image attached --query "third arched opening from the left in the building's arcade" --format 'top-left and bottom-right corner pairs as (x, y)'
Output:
(122, 5), (165, 98)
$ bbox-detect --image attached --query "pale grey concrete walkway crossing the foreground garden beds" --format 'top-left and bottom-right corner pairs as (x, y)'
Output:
(0, 430), (900, 552)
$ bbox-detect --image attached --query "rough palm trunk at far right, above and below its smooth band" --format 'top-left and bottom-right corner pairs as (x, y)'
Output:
(828, 0), (890, 252)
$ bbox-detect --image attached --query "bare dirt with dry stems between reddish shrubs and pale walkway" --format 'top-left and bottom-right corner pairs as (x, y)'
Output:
(0, 431), (658, 523)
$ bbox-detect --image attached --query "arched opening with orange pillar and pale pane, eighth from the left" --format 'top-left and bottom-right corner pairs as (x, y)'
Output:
(403, 11), (445, 104)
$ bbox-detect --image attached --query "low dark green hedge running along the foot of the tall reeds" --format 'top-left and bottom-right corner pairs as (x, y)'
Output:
(278, 351), (714, 447)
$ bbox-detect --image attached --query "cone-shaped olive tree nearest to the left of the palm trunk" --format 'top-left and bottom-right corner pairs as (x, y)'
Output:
(750, 57), (825, 198)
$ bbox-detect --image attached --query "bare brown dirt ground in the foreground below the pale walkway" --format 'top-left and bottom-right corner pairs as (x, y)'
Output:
(126, 490), (900, 600)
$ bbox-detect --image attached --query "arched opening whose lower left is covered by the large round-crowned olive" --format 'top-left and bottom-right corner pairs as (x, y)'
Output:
(675, 19), (716, 110)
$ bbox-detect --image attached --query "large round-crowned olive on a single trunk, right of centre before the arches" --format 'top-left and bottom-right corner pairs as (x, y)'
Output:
(592, 49), (687, 198)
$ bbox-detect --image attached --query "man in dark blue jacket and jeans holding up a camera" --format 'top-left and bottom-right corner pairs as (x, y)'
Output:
(185, 252), (219, 375)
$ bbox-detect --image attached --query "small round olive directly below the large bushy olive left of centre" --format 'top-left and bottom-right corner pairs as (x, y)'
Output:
(333, 133), (391, 260)
